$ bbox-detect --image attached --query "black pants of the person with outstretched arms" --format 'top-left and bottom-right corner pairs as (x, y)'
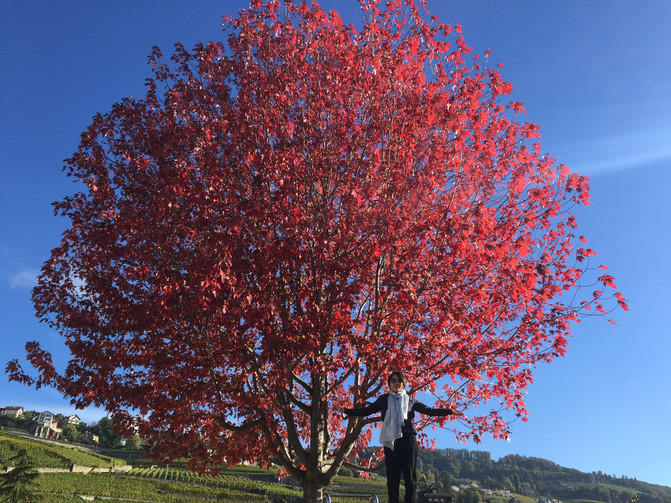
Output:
(384, 433), (417, 503)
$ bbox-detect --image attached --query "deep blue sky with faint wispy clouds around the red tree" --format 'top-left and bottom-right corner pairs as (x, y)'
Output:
(0, 0), (671, 486)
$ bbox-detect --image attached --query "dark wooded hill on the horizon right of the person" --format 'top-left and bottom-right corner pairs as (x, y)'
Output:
(418, 449), (671, 503)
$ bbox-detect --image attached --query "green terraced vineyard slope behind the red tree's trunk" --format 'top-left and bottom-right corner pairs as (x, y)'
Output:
(0, 433), (386, 503)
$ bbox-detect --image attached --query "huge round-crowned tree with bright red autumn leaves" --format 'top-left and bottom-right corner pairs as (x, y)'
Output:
(7, 0), (626, 501)
